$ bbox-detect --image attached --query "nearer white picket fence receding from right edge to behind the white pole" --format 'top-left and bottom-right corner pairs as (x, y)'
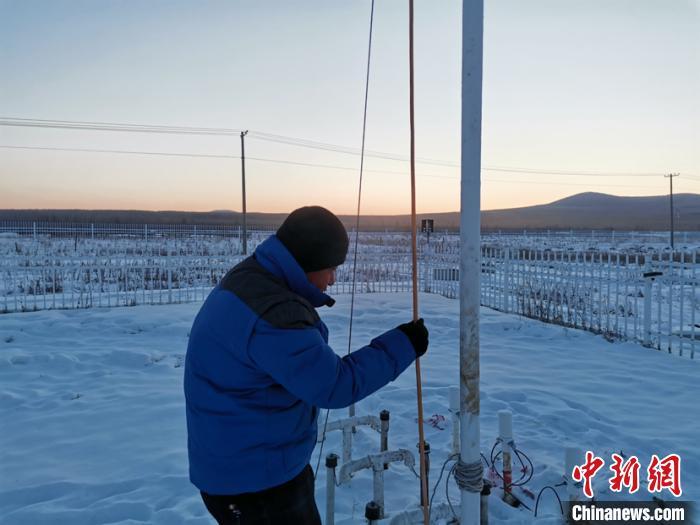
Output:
(423, 247), (700, 358)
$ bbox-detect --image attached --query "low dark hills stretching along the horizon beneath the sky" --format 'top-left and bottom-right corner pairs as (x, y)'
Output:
(0, 193), (700, 231)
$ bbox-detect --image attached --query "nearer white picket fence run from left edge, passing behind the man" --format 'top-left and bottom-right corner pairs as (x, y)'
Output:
(0, 255), (412, 313)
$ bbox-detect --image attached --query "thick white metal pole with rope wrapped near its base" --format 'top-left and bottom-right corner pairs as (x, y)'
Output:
(459, 0), (484, 525)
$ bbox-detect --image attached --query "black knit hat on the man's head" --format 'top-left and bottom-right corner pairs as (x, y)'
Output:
(277, 206), (348, 272)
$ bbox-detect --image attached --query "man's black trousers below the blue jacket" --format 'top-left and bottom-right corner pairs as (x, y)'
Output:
(201, 465), (321, 525)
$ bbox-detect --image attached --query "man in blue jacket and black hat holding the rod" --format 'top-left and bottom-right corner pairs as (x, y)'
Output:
(185, 206), (428, 525)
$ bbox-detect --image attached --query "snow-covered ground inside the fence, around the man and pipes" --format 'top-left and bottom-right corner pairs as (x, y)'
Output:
(0, 294), (700, 525)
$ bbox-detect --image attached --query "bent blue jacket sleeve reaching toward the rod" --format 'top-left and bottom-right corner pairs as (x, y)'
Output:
(248, 319), (416, 408)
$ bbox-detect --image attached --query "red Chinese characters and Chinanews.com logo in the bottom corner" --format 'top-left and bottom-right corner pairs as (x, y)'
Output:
(569, 451), (694, 524)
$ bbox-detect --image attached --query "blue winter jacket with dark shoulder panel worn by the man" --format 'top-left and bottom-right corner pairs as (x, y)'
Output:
(184, 235), (415, 494)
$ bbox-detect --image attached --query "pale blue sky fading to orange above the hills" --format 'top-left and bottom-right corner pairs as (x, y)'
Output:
(0, 0), (700, 214)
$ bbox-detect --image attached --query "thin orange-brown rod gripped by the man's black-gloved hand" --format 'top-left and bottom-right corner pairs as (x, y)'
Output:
(408, 0), (430, 525)
